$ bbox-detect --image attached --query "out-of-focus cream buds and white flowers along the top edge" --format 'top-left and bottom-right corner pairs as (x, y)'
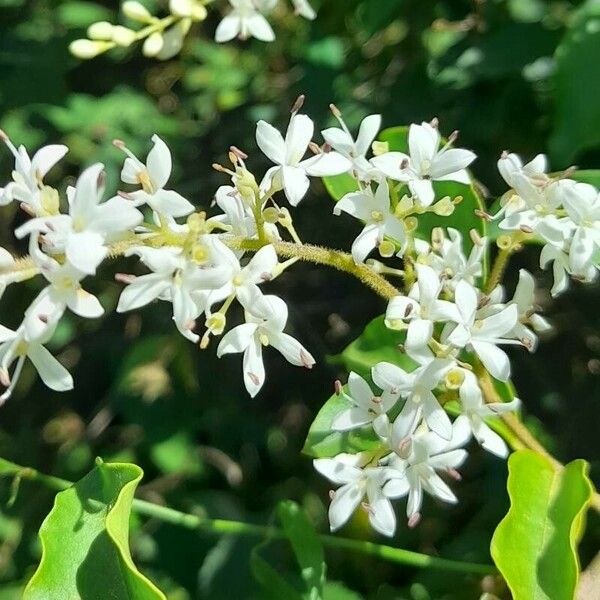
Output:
(70, 0), (316, 60)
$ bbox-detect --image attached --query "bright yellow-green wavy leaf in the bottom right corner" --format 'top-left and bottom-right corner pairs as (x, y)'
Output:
(491, 450), (593, 600)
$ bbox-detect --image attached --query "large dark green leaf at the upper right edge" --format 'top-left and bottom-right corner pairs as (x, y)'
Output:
(550, 0), (600, 166)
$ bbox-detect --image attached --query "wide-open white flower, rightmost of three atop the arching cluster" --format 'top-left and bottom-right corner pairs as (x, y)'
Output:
(371, 123), (476, 206)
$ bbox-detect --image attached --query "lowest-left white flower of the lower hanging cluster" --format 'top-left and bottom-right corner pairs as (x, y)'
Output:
(313, 454), (404, 537)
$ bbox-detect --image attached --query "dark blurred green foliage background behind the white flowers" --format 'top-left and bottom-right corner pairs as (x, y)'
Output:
(0, 0), (600, 600)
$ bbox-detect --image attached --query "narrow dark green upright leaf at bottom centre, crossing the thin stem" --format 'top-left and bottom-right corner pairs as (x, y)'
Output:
(277, 500), (325, 600)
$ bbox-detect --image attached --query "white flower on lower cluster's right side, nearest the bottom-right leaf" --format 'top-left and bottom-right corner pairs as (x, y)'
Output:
(457, 369), (520, 458)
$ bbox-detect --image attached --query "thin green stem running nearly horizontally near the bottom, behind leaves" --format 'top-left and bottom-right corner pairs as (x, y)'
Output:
(0, 459), (496, 575)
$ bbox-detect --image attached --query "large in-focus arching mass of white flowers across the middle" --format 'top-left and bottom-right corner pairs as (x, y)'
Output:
(0, 101), (600, 535)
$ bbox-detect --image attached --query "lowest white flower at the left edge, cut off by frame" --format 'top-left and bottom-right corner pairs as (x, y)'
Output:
(0, 325), (73, 404)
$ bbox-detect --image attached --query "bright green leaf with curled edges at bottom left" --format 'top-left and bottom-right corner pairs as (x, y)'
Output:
(23, 463), (165, 600)
